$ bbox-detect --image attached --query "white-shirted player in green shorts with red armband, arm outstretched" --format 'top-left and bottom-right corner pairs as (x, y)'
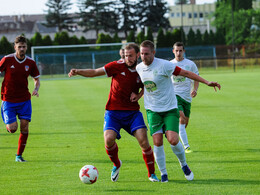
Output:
(136, 40), (220, 182)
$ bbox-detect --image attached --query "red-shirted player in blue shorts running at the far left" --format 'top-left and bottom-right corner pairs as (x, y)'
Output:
(0, 36), (40, 162)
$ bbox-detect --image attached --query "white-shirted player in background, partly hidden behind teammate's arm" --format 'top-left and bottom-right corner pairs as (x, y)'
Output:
(171, 42), (199, 153)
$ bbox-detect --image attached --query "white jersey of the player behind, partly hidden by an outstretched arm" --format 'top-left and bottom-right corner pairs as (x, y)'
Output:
(171, 58), (199, 103)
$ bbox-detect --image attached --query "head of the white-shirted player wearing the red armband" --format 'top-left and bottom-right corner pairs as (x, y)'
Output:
(140, 40), (155, 66)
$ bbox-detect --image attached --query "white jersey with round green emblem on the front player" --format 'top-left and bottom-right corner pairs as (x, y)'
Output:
(136, 58), (177, 112)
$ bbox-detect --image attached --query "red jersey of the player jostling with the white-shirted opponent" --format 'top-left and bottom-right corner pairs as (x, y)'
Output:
(104, 60), (143, 110)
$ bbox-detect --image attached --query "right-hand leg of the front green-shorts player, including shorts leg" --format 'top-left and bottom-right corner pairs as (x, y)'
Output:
(164, 109), (193, 180)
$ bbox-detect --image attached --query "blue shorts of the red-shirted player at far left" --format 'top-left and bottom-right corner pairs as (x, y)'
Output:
(1, 100), (32, 124)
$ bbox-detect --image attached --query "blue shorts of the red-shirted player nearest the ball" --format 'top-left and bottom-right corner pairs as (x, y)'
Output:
(104, 110), (147, 139)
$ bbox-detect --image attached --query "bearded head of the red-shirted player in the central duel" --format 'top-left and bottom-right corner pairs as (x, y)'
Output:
(125, 43), (140, 68)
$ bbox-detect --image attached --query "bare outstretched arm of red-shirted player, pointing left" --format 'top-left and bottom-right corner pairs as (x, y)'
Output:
(68, 67), (106, 77)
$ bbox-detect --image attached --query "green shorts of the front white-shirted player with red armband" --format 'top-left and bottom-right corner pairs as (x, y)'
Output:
(146, 108), (180, 135)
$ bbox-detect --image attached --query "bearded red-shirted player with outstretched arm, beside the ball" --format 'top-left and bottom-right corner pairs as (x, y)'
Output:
(68, 44), (159, 182)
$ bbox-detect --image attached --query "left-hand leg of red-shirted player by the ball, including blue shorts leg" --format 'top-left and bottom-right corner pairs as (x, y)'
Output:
(104, 111), (122, 182)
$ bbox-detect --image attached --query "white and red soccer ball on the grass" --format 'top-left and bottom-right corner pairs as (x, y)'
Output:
(79, 165), (98, 184)
